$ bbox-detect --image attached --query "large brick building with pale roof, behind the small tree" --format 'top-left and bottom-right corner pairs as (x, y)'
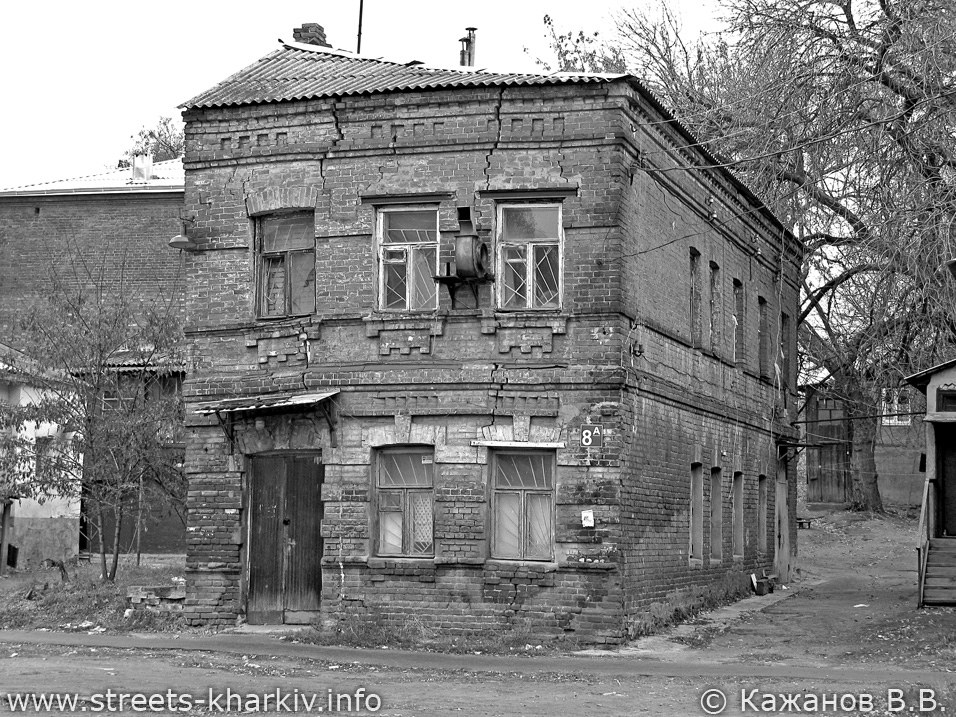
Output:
(0, 157), (185, 552)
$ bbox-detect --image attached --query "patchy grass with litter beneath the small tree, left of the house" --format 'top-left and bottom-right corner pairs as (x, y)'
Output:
(0, 561), (184, 632)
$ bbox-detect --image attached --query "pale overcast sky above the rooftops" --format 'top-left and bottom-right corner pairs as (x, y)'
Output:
(0, 0), (714, 187)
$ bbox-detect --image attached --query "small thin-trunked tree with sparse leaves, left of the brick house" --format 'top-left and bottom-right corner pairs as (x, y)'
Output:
(0, 251), (185, 581)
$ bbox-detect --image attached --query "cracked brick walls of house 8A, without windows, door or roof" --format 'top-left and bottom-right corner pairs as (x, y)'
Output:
(179, 83), (799, 642)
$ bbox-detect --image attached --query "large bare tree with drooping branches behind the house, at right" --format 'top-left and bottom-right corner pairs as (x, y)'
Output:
(544, 0), (956, 510)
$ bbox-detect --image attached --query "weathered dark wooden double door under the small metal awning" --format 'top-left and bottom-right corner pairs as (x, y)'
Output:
(246, 454), (324, 625)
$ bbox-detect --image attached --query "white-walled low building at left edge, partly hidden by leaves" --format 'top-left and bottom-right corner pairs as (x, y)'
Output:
(0, 344), (80, 572)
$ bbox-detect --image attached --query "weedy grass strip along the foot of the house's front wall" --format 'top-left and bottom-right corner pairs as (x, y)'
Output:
(298, 614), (582, 655)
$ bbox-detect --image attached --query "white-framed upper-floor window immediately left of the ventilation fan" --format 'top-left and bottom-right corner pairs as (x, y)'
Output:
(378, 209), (438, 311)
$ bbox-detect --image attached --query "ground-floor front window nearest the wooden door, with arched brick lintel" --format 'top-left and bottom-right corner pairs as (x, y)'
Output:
(376, 449), (435, 557)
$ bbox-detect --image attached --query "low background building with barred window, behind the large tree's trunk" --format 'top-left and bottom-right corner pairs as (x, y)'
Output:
(801, 386), (925, 507)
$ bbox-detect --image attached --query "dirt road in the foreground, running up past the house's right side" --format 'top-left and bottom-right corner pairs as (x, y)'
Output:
(0, 506), (956, 717)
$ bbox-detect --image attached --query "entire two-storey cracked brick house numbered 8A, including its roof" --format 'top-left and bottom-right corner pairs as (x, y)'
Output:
(177, 30), (801, 643)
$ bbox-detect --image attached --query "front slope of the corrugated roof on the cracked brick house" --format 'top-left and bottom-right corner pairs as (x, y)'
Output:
(182, 43), (624, 108)
